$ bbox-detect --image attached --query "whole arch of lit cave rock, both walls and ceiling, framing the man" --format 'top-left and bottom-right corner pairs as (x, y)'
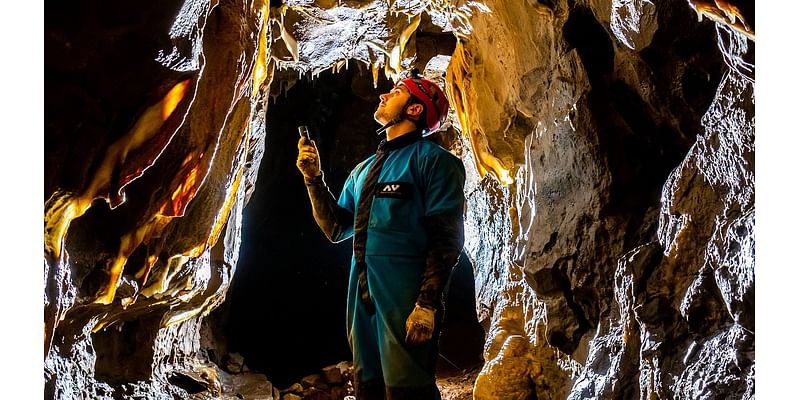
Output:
(44, 0), (755, 399)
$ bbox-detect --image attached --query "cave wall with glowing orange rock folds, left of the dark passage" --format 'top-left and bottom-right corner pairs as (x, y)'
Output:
(44, 1), (269, 399)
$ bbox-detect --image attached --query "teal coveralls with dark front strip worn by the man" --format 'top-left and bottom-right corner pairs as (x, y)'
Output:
(307, 132), (465, 400)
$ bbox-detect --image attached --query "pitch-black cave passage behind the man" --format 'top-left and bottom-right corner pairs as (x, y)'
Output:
(210, 63), (483, 387)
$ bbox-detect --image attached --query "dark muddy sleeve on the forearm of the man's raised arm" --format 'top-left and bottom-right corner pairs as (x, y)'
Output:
(305, 174), (353, 243)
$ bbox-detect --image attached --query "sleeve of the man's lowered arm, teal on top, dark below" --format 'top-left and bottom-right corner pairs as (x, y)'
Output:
(417, 153), (465, 309)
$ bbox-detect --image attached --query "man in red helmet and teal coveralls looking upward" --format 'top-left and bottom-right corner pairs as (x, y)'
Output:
(297, 74), (465, 400)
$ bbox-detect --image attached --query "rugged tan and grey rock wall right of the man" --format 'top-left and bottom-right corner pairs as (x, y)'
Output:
(448, 1), (755, 399)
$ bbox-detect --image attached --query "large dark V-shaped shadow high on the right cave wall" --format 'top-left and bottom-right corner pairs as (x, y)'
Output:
(563, 4), (725, 225)
